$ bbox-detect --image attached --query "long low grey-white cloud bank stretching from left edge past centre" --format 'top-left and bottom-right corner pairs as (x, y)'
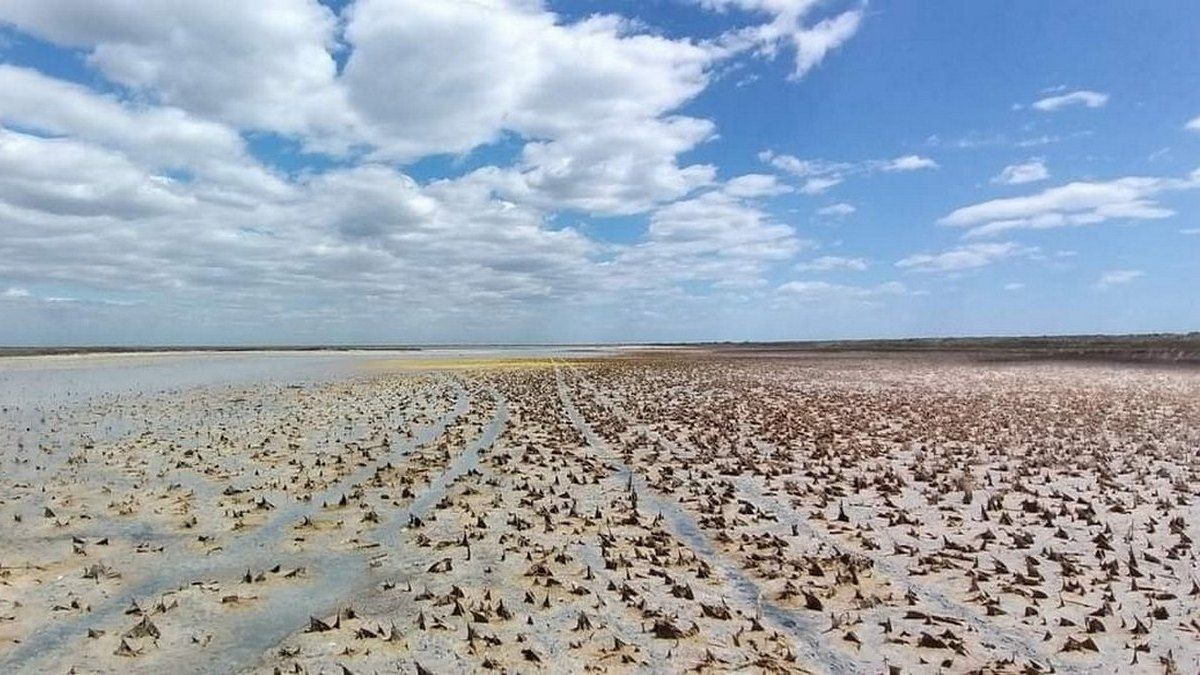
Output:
(0, 131), (810, 331)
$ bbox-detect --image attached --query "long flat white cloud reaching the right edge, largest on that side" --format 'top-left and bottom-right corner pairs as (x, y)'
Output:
(938, 169), (1200, 237)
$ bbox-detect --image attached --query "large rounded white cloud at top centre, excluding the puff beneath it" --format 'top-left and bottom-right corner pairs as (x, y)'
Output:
(344, 0), (719, 159)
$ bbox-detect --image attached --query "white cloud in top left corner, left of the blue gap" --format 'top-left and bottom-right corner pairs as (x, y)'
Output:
(0, 0), (353, 141)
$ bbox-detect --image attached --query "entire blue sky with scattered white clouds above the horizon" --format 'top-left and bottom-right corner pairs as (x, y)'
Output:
(0, 0), (1200, 345)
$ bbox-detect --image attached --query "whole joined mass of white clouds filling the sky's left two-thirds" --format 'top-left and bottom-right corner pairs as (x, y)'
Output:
(0, 0), (873, 340)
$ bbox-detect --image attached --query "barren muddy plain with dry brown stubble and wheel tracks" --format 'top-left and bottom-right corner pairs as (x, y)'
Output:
(0, 347), (1200, 674)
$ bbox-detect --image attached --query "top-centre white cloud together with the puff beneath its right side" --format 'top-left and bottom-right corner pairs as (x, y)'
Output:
(343, 0), (722, 215)
